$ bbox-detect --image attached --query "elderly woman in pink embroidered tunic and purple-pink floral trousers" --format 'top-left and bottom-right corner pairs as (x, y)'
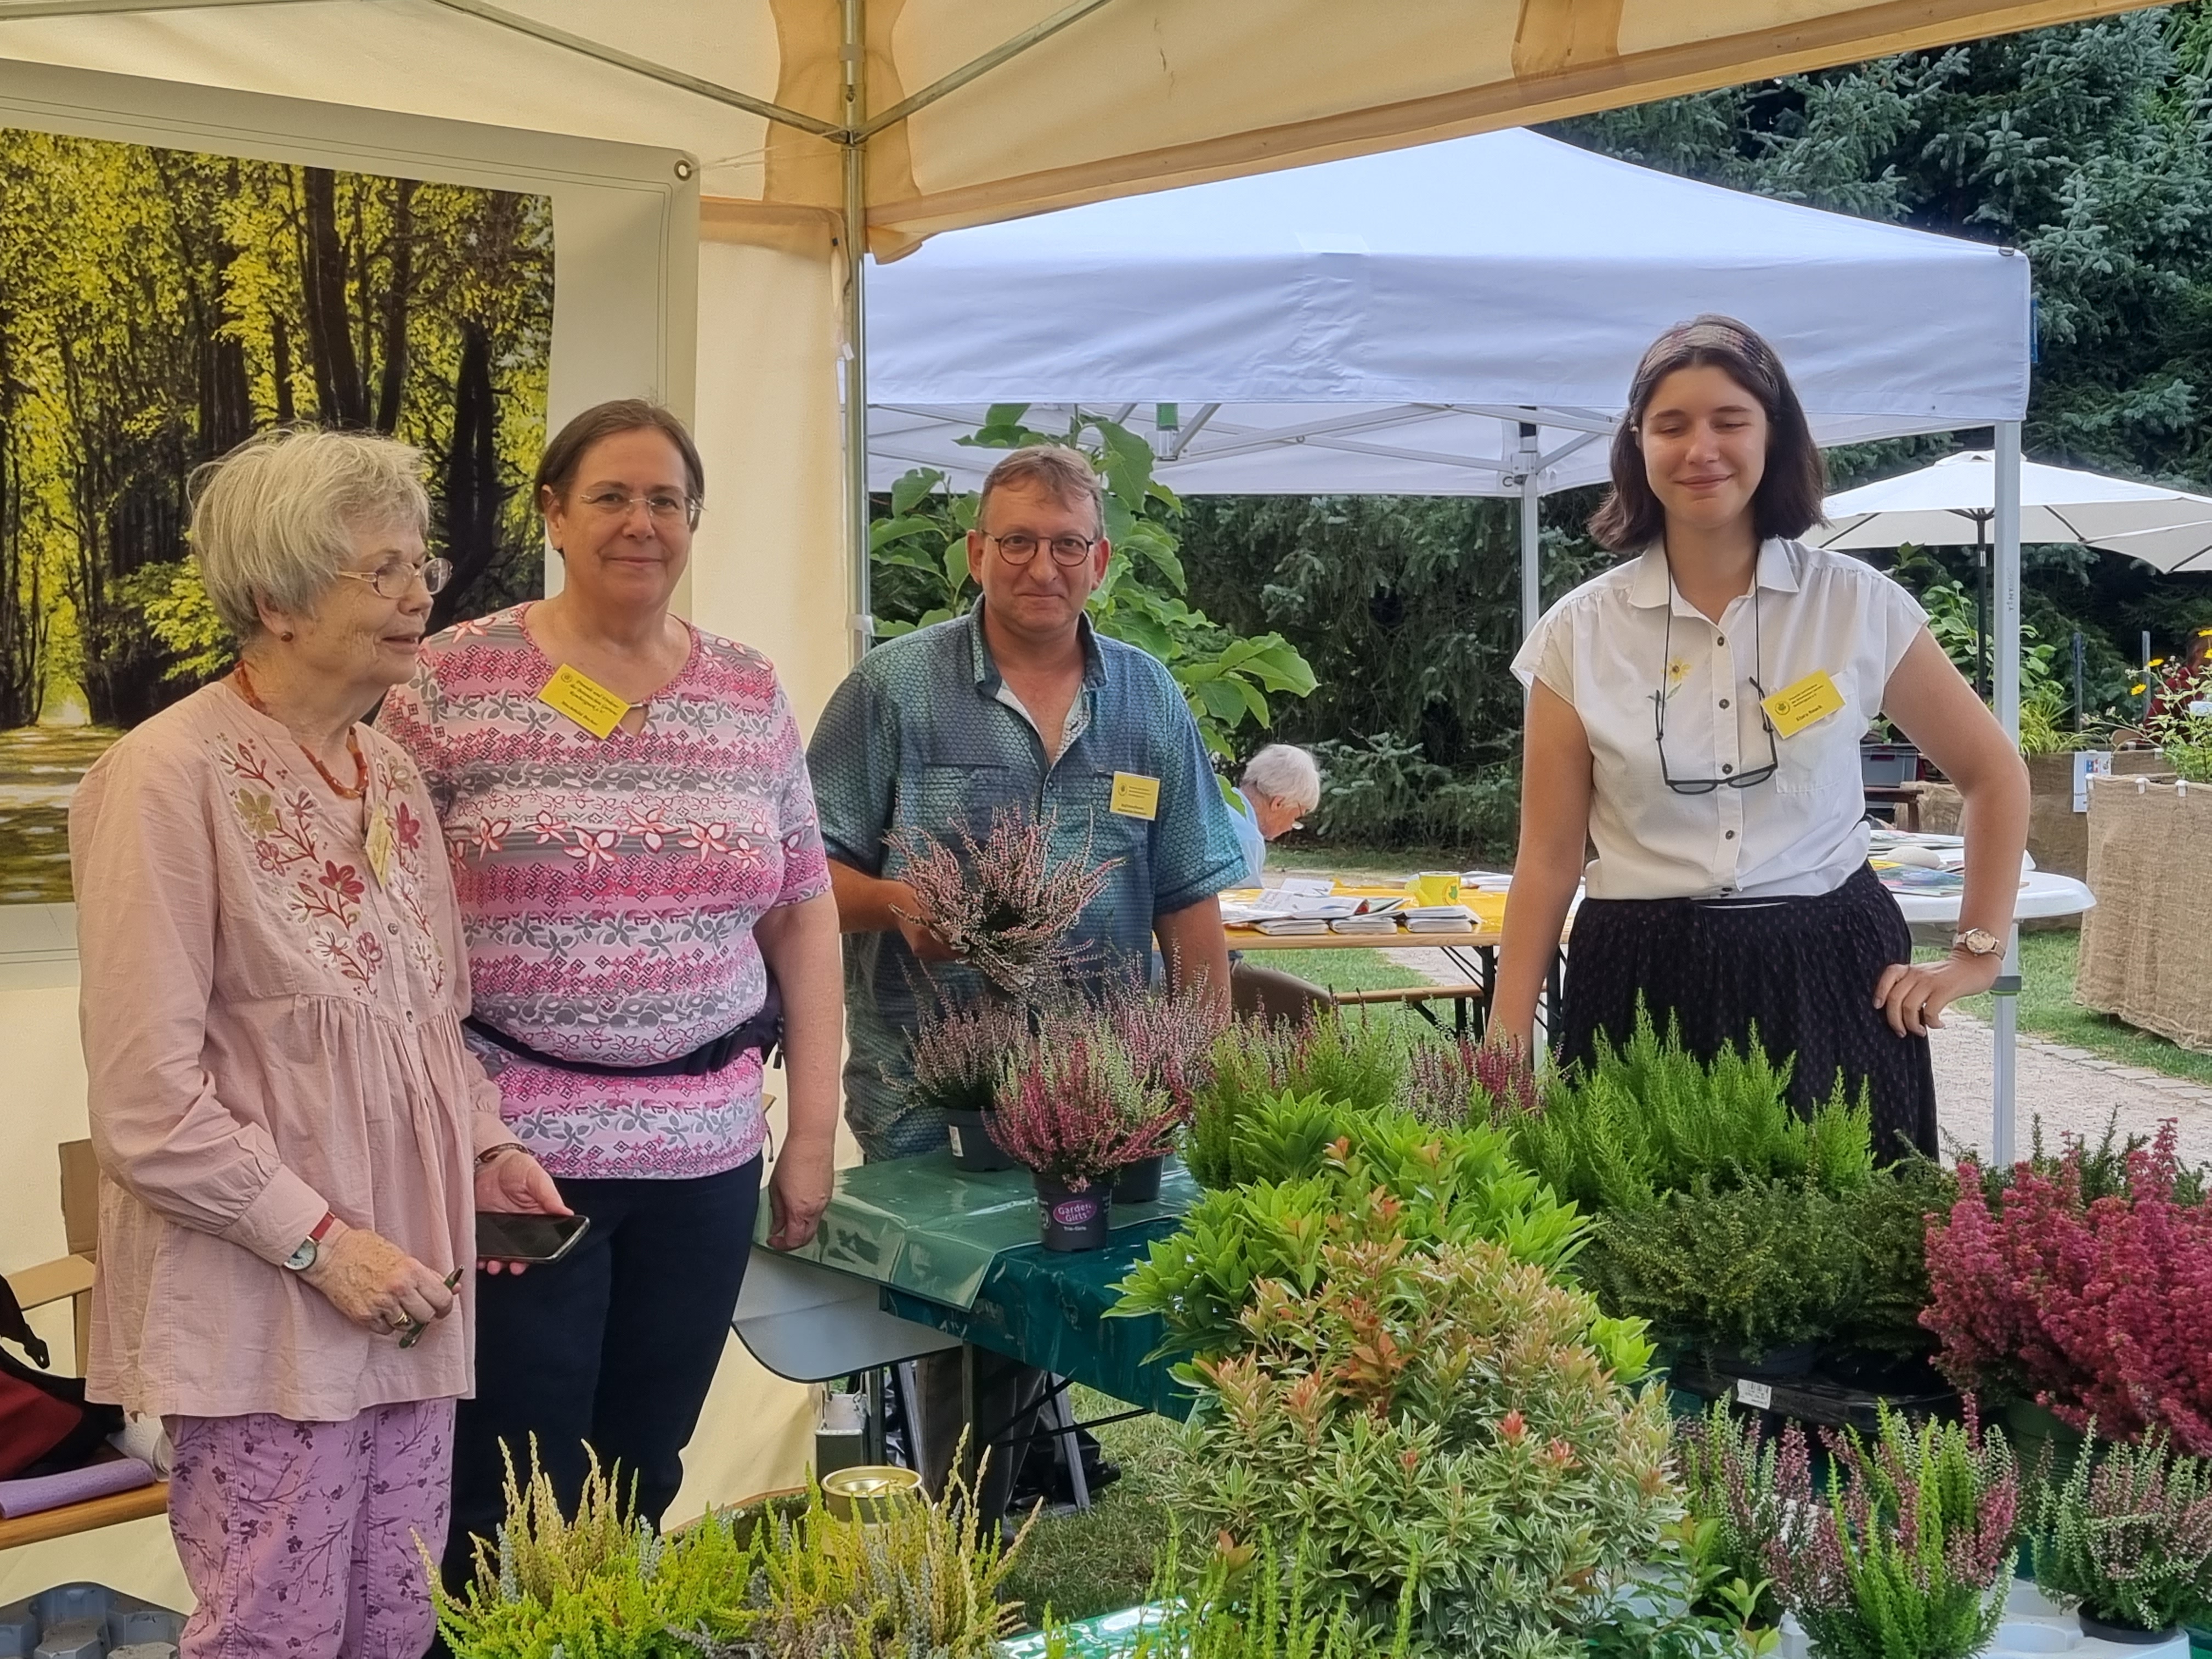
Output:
(69, 431), (562, 1659)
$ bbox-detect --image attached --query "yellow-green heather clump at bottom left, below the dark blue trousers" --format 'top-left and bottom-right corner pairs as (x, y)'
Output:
(422, 1449), (1026, 1659)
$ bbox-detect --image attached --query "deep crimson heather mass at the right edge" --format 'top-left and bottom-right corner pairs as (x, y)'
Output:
(1920, 1121), (2212, 1453)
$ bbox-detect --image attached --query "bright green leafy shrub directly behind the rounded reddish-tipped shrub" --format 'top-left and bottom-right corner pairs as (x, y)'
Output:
(1113, 1110), (1601, 1374)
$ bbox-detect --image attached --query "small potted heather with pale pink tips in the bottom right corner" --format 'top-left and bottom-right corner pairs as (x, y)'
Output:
(2028, 1423), (2212, 1644)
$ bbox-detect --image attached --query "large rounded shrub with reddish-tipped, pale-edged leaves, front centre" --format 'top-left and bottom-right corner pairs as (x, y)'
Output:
(1177, 1237), (1681, 1659)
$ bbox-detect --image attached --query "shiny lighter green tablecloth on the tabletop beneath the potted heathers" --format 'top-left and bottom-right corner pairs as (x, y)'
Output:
(754, 1150), (1199, 1307)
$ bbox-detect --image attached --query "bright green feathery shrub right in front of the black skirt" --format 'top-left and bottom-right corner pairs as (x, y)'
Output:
(1509, 1011), (1874, 1210)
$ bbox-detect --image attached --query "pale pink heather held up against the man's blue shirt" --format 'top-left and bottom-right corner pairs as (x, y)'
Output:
(885, 808), (1121, 1000)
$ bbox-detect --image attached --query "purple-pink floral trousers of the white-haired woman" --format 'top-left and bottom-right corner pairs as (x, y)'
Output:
(168, 1400), (454, 1659)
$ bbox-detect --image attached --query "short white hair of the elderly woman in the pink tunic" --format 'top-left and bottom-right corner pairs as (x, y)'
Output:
(190, 427), (429, 641)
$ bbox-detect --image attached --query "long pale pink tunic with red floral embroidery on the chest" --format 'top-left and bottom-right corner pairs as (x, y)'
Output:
(69, 684), (511, 1423)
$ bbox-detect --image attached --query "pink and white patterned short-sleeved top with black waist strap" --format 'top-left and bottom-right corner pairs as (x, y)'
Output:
(376, 604), (830, 1179)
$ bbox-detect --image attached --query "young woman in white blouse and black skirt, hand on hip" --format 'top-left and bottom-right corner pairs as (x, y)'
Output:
(1493, 317), (2028, 1157)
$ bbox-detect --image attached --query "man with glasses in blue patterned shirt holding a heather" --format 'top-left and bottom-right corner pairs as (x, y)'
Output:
(808, 447), (1245, 1159)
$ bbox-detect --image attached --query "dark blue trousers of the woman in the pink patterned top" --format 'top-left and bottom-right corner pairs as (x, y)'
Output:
(444, 1157), (761, 1590)
